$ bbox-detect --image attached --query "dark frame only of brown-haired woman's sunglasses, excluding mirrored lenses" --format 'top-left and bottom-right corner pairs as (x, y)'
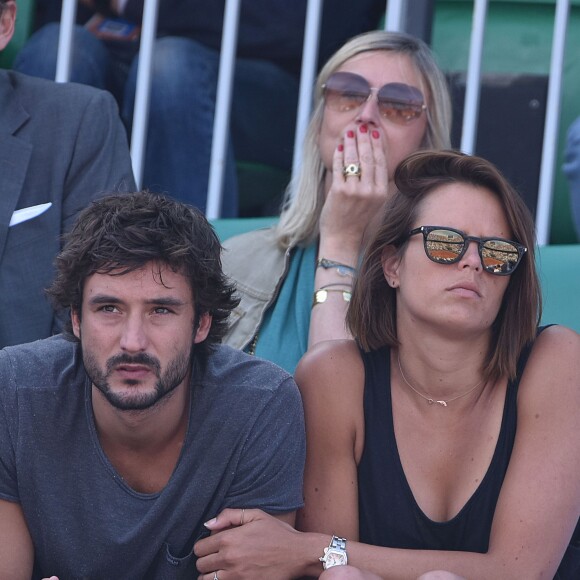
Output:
(407, 226), (528, 276)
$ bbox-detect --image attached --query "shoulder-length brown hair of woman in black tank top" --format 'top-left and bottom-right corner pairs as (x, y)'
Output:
(347, 151), (542, 380)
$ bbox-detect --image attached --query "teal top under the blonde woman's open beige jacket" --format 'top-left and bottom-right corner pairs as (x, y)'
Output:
(255, 244), (316, 374)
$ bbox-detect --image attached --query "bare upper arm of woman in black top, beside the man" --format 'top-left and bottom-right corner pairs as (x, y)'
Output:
(296, 340), (364, 540)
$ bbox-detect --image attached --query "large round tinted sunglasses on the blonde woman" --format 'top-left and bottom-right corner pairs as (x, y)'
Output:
(322, 72), (427, 125)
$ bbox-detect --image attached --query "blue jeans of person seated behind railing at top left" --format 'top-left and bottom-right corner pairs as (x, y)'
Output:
(14, 23), (298, 217)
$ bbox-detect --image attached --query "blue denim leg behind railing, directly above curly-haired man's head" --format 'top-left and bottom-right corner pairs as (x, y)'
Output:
(123, 36), (237, 217)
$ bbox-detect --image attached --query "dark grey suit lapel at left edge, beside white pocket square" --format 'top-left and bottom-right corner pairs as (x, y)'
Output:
(0, 71), (32, 258)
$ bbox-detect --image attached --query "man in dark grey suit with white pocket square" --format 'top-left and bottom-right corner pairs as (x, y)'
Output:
(0, 0), (136, 348)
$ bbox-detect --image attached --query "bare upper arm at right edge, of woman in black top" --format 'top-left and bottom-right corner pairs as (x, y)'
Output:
(480, 326), (580, 578)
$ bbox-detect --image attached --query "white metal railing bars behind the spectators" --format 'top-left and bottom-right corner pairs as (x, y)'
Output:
(56, 0), (570, 245)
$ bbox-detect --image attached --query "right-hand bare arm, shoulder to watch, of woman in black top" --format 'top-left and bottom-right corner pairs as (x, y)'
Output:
(306, 327), (580, 580)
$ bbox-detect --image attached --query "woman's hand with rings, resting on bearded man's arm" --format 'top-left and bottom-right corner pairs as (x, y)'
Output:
(194, 509), (314, 580)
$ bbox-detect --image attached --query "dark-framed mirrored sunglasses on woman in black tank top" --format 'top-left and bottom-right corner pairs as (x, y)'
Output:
(407, 226), (528, 276)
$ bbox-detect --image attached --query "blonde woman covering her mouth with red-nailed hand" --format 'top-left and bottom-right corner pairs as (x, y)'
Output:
(223, 31), (451, 372)
